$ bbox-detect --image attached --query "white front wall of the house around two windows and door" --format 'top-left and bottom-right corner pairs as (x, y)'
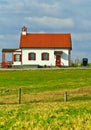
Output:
(22, 49), (69, 66)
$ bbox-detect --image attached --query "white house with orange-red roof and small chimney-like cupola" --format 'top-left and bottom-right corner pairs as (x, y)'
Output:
(2, 26), (72, 67)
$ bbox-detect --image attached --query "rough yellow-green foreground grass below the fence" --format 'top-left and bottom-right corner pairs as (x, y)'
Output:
(0, 101), (91, 130)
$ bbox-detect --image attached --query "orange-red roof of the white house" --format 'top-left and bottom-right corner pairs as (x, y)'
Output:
(20, 34), (72, 49)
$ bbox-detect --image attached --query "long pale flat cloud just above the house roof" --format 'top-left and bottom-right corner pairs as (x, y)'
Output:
(26, 16), (74, 28)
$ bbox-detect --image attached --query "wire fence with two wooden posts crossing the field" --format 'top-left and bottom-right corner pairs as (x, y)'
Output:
(0, 88), (91, 105)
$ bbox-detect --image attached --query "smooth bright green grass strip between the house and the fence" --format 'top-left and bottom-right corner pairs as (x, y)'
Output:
(0, 69), (91, 92)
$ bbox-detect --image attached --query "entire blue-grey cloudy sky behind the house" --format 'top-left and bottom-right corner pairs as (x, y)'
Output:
(0, 0), (91, 62)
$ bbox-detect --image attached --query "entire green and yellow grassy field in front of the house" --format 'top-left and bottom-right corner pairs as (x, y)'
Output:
(0, 69), (91, 130)
